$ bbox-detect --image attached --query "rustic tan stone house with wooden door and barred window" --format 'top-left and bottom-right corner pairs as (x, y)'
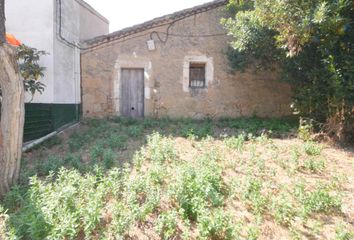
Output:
(81, 0), (291, 119)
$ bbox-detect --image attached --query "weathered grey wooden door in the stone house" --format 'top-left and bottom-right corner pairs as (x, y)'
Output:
(121, 68), (144, 118)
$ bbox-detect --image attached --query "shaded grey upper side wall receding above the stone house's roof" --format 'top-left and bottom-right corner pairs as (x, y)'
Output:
(76, 0), (109, 41)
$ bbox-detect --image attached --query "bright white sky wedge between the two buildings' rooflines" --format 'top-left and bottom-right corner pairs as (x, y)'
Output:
(85, 0), (211, 32)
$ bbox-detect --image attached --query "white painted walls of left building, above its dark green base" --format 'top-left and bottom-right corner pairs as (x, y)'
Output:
(5, 0), (109, 104)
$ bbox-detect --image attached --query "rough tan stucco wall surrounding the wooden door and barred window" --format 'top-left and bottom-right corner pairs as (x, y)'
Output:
(81, 7), (291, 118)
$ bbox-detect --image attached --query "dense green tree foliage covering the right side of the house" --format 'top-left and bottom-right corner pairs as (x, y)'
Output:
(222, 0), (354, 142)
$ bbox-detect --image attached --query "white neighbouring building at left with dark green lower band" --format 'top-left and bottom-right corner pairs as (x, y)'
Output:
(5, 0), (109, 141)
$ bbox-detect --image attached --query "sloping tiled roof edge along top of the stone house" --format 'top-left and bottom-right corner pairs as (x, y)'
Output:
(84, 0), (229, 45)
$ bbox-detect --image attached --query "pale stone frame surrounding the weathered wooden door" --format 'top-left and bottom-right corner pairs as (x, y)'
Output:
(112, 55), (154, 117)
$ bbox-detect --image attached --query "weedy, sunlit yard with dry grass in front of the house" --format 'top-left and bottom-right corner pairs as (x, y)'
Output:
(0, 118), (354, 240)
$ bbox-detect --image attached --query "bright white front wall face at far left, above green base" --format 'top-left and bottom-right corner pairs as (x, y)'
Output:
(5, 0), (55, 103)
